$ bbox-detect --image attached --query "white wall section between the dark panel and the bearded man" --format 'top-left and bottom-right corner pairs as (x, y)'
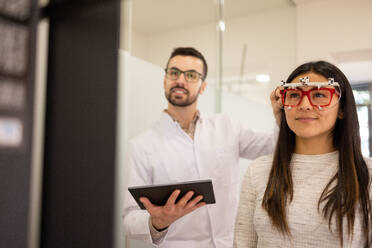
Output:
(115, 51), (166, 248)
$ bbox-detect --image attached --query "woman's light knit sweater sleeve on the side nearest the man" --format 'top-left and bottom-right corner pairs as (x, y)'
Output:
(234, 167), (257, 248)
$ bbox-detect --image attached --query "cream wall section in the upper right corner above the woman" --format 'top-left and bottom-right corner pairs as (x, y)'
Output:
(296, 0), (372, 64)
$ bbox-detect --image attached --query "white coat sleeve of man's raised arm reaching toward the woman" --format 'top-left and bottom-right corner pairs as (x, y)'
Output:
(239, 121), (279, 159)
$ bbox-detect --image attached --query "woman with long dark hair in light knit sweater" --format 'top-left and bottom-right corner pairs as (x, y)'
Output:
(234, 61), (372, 248)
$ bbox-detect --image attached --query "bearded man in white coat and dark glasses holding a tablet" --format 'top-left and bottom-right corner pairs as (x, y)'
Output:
(123, 47), (280, 248)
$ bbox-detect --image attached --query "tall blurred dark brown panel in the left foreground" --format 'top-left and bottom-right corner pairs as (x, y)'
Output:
(41, 0), (120, 248)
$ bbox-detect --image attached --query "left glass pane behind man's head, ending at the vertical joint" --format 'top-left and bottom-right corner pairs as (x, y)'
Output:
(116, 0), (219, 248)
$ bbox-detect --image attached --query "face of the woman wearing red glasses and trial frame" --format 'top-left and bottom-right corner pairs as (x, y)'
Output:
(284, 72), (339, 139)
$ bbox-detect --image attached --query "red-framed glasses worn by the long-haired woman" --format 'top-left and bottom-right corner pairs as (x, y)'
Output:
(280, 87), (340, 109)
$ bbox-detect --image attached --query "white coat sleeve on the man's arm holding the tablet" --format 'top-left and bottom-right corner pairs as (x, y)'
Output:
(123, 142), (167, 246)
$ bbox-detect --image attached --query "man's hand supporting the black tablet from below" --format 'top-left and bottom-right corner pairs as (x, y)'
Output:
(140, 189), (205, 229)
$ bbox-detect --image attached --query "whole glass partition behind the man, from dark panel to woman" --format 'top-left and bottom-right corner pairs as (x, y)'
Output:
(118, 0), (296, 248)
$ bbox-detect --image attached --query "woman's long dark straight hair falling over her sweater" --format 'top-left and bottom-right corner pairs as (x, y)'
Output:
(262, 61), (372, 248)
